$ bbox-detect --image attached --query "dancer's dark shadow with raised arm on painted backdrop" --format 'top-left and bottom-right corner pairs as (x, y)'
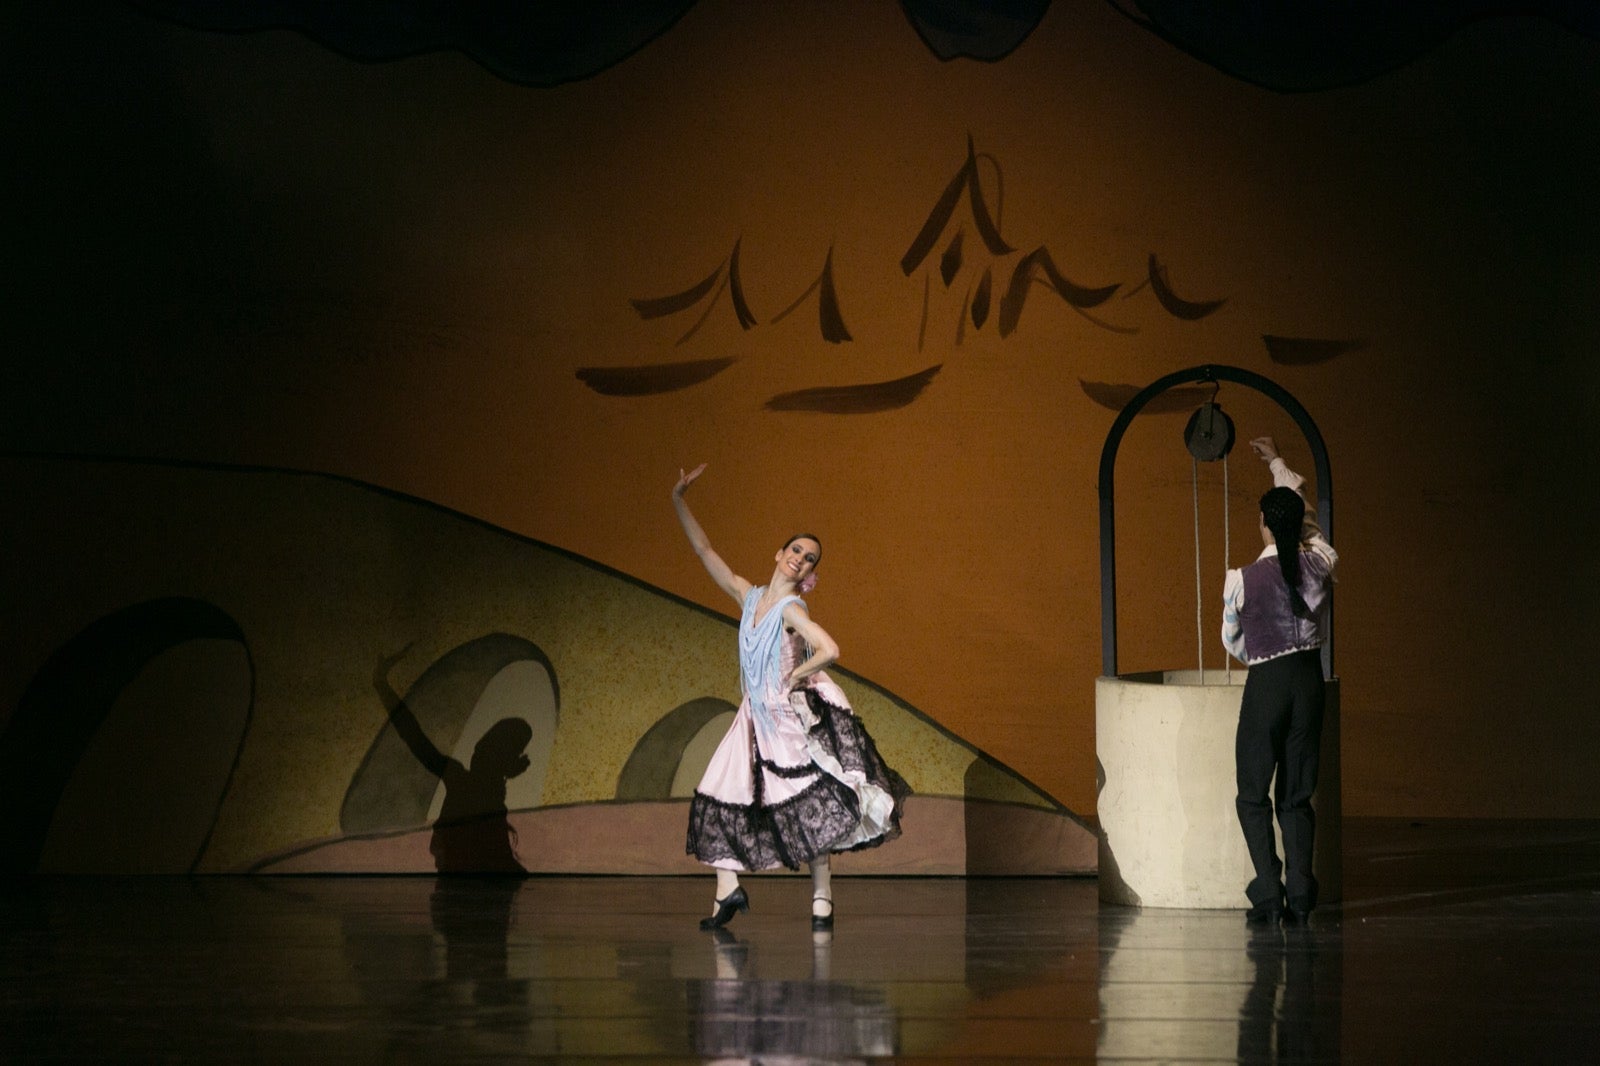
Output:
(373, 645), (533, 874)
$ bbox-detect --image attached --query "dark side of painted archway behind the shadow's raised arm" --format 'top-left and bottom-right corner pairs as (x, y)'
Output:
(339, 634), (562, 834)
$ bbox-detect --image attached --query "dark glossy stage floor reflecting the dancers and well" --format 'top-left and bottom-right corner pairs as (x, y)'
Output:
(0, 820), (1600, 1066)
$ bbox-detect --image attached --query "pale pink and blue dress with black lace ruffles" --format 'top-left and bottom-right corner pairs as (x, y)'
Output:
(686, 587), (910, 871)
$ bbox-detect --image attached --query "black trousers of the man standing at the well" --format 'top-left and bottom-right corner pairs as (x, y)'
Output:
(1234, 648), (1323, 909)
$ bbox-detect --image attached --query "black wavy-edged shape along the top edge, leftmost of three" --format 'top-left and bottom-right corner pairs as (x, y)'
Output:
(134, 0), (694, 86)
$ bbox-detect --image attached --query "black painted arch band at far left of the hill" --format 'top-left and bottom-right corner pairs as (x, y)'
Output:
(0, 597), (256, 874)
